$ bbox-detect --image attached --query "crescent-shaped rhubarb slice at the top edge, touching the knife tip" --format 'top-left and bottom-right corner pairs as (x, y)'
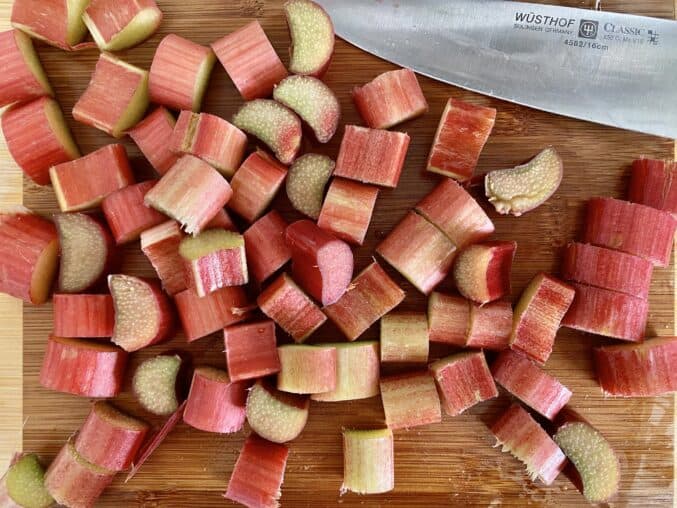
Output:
(284, 0), (334, 77)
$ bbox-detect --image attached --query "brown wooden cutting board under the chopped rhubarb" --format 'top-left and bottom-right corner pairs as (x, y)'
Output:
(0, 0), (675, 507)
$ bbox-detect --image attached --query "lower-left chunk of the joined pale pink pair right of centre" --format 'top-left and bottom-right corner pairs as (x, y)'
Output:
(376, 212), (456, 295)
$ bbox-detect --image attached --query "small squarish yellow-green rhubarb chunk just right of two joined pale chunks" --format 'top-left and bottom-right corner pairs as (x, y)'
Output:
(381, 312), (429, 363)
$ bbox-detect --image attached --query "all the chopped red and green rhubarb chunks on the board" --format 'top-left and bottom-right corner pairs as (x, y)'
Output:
(0, 0), (677, 508)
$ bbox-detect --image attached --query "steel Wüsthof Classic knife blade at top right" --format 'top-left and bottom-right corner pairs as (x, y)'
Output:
(317, 0), (677, 139)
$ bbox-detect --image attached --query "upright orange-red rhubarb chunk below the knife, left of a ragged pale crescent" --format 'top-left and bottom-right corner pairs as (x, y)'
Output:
(428, 98), (496, 182)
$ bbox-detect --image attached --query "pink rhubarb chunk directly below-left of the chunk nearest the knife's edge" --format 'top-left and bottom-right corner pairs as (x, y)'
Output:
(334, 125), (410, 188)
